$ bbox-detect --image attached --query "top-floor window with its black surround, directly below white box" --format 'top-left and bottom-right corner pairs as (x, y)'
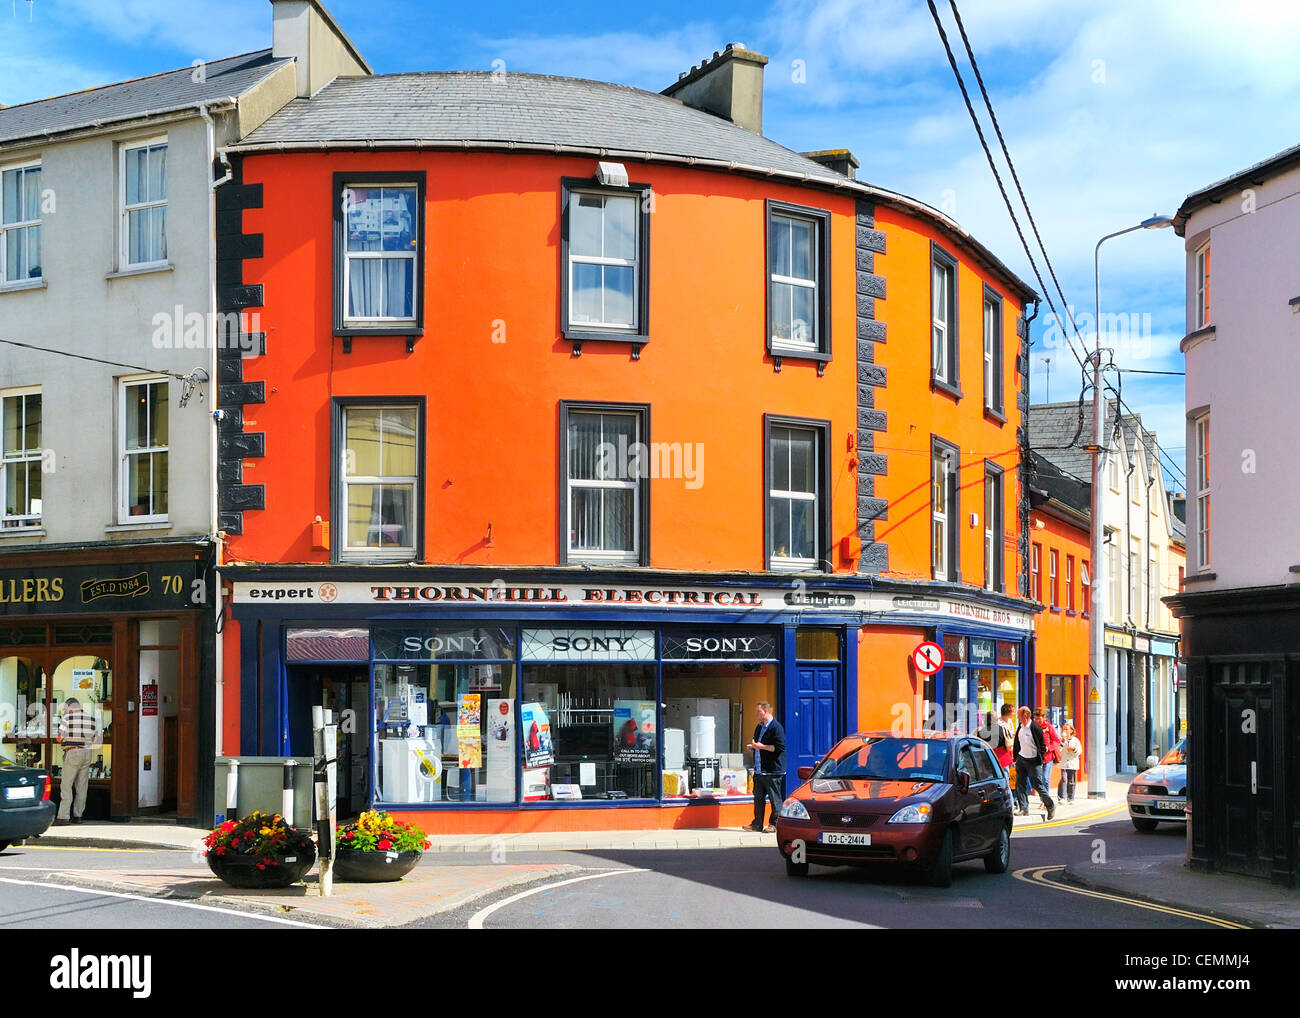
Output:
(562, 178), (650, 339)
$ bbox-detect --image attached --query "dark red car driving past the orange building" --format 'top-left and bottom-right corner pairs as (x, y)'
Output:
(776, 732), (1011, 887)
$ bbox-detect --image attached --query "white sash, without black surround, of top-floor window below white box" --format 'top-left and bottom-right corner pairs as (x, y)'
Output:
(566, 190), (644, 332)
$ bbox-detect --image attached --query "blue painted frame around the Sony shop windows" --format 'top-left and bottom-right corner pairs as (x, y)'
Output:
(237, 603), (861, 811)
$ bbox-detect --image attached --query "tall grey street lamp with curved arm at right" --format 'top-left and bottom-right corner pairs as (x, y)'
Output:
(1087, 216), (1174, 798)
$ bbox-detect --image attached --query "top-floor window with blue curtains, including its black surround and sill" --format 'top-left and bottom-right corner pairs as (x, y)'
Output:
(334, 172), (425, 335)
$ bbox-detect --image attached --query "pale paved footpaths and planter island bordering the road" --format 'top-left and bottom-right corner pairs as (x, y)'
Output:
(12, 779), (1300, 928)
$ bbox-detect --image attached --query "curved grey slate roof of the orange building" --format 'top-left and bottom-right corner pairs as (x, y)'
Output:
(230, 72), (1036, 299)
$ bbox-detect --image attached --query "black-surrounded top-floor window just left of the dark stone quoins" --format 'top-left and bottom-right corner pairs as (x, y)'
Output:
(767, 202), (831, 360)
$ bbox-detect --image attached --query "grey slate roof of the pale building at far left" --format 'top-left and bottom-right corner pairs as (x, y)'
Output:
(0, 49), (293, 144)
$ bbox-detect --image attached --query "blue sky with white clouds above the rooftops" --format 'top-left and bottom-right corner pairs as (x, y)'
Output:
(0, 0), (1300, 488)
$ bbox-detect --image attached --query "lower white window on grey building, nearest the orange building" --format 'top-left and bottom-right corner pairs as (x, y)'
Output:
(117, 374), (169, 524)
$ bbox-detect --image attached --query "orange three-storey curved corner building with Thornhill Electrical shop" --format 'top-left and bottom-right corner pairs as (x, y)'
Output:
(217, 47), (1034, 832)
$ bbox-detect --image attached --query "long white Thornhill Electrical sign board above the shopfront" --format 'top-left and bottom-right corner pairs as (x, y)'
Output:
(234, 580), (1034, 631)
